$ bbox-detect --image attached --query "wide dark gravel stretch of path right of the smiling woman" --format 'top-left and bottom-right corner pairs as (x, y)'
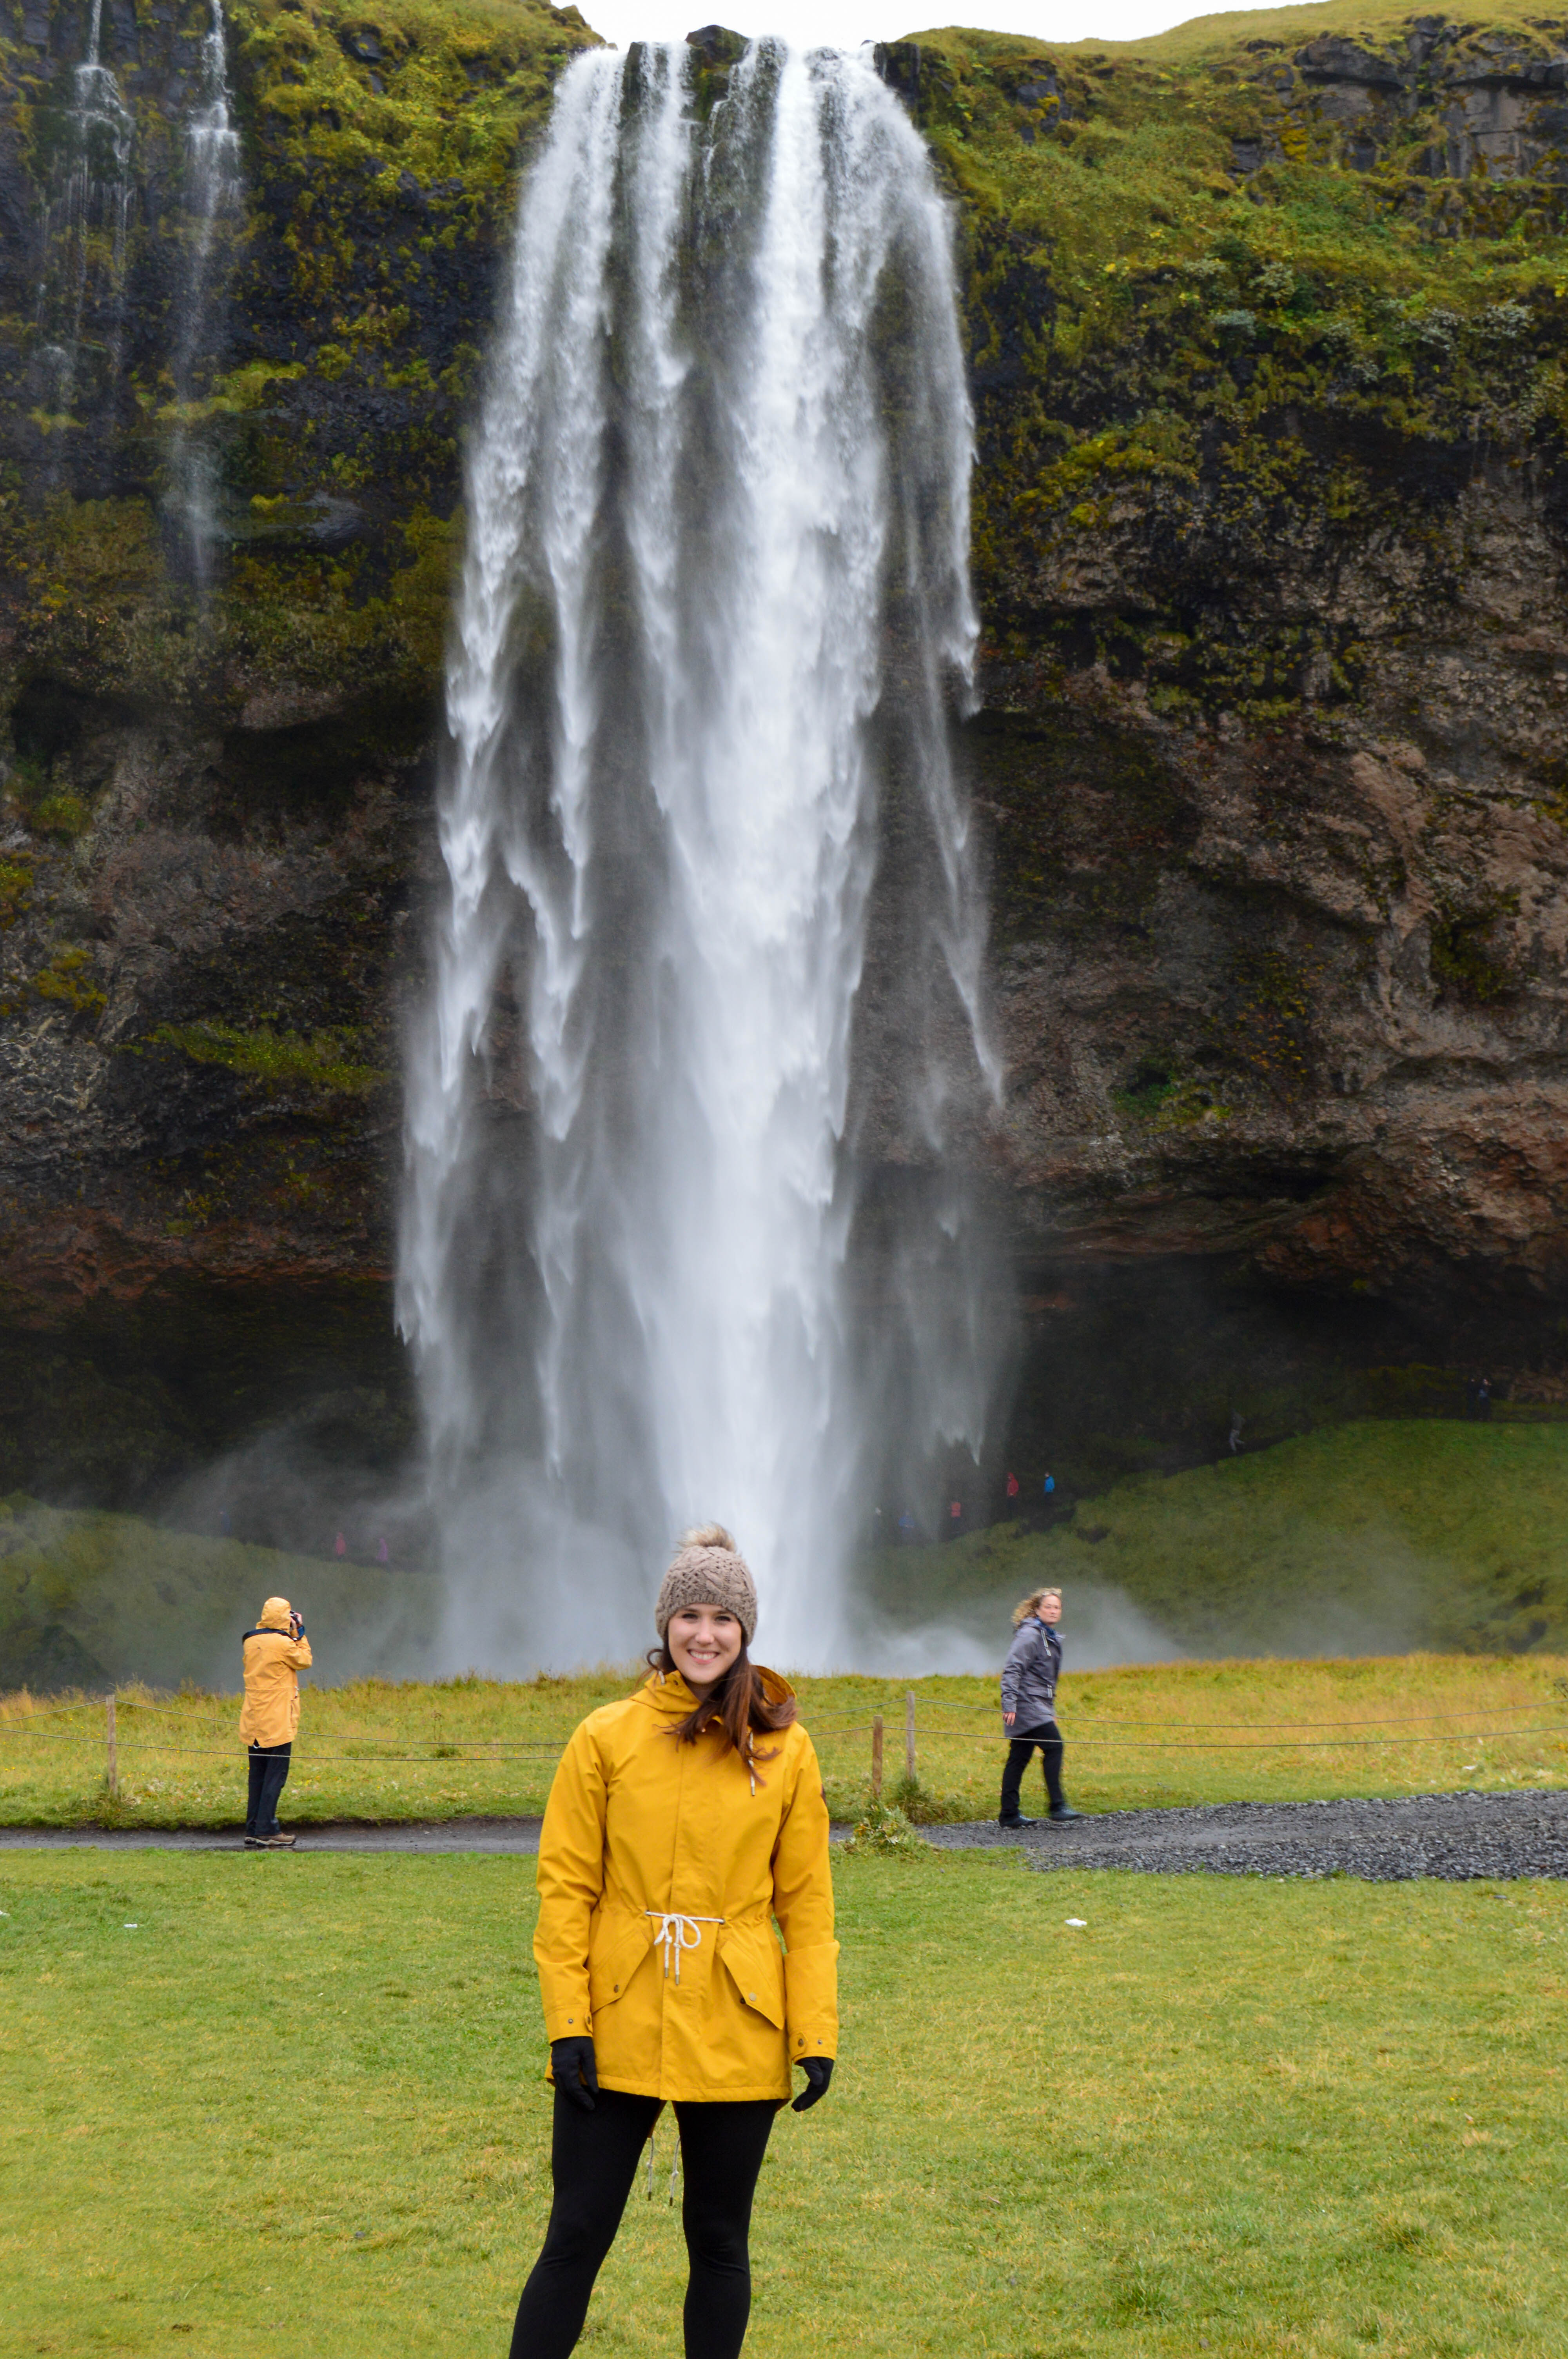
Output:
(924, 1788), (1568, 1885)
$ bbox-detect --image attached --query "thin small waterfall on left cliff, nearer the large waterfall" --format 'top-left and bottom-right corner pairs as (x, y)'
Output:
(170, 0), (243, 587)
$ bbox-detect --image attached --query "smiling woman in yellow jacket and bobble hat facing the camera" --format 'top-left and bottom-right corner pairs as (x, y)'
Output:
(512, 1524), (839, 2359)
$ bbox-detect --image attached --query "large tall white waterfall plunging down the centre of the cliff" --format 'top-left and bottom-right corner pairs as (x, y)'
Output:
(399, 40), (995, 1668)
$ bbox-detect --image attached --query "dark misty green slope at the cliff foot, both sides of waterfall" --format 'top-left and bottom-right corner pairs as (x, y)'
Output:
(0, 1418), (1568, 1691)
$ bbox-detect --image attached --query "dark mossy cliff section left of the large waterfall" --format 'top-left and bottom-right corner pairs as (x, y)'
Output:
(0, 0), (592, 1498)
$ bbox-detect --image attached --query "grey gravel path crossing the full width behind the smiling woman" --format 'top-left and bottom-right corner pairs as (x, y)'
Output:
(0, 1790), (1568, 1883)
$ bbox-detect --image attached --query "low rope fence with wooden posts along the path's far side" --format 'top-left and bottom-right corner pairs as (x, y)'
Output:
(0, 1689), (1568, 1795)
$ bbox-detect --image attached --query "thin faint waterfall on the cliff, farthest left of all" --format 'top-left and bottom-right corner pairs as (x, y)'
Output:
(40, 0), (134, 418)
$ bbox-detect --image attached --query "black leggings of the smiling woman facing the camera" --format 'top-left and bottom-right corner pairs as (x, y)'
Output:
(512, 2088), (778, 2359)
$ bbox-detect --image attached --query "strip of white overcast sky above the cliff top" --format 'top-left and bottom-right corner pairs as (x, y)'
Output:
(578, 0), (1283, 49)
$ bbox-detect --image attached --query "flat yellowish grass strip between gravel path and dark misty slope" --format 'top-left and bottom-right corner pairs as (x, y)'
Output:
(0, 1651), (1568, 1826)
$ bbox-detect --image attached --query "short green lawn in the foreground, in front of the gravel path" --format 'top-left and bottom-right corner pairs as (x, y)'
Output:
(0, 1854), (1568, 2359)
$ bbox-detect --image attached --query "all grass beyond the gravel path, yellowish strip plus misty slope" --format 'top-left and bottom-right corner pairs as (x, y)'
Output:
(0, 1420), (1568, 1826)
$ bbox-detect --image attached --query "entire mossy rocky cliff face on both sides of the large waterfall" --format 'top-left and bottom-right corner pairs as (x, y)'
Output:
(0, 0), (1568, 1498)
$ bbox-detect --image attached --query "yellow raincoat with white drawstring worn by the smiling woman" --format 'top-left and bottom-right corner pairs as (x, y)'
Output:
(533, 1672), (839, 2102)
